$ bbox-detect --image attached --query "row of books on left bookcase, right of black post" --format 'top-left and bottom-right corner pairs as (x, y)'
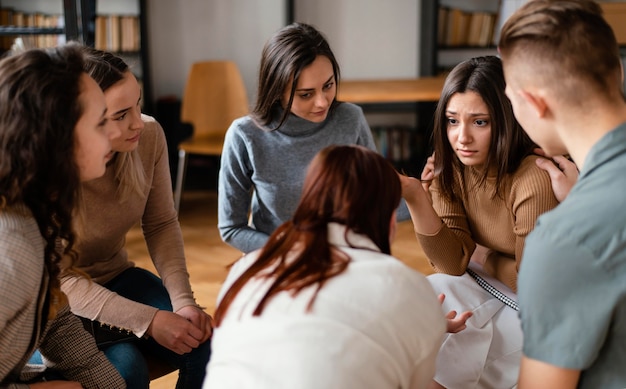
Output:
(94, 15), (141, 52)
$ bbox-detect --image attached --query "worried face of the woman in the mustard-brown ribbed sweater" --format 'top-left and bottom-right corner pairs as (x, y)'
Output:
(446, 91), (491, 166)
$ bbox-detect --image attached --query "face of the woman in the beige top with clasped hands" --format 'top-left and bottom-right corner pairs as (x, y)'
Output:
(104, 71), (144, 152)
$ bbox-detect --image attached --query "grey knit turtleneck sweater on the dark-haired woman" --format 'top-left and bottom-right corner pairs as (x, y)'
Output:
(218, 103), (376, 253)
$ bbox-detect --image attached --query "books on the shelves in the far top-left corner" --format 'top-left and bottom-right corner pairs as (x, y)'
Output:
(0, 8), (65, 51)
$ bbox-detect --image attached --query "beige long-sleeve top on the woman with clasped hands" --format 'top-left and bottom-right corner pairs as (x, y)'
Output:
(61, 115), (197, 337)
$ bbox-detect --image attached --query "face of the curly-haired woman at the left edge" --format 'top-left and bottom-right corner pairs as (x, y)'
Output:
(74, 73), (120, 181)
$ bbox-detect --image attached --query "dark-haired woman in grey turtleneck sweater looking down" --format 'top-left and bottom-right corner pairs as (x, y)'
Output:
(218, 23), (375, 253)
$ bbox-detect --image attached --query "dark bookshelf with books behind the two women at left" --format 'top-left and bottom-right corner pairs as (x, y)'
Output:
(0, 0), (153, 114)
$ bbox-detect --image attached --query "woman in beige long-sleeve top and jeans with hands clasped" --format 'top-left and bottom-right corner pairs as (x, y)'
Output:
(62, 47), (212, 389)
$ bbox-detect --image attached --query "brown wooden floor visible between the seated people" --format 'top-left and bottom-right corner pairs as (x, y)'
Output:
(126, 191), (432, 389)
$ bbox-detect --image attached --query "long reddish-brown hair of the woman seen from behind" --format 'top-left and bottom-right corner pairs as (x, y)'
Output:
(215, 145), (401, 326)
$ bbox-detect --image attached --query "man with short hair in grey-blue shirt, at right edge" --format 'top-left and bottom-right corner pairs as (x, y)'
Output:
(499, 0), (626, 389)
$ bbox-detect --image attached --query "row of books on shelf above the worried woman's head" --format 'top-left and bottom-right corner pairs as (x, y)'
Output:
(437, 7), (498, 47)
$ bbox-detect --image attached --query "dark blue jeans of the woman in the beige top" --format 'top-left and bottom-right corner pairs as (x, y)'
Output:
(102, 267), (211, 389)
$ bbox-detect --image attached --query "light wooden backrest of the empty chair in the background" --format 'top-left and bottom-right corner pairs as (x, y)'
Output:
(181, 61), (249, 138)
